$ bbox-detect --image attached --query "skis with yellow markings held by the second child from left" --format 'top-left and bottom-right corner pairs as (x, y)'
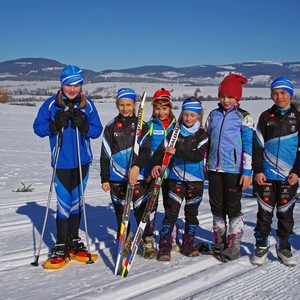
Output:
(114, 92), (146, 275)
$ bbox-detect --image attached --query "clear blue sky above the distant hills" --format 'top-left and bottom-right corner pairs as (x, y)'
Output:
(0, 0), (300, 71)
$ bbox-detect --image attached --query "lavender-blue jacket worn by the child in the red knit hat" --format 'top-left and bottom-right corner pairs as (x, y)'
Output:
(206, 103), (254, 176)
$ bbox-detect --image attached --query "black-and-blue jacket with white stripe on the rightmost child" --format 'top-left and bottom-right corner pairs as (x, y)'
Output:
(253, 105), (300, 181)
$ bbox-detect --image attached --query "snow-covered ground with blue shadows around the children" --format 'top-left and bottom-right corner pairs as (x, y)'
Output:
(0, 86), (300, 300)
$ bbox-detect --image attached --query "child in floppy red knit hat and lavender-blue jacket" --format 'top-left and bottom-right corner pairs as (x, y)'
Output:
(206, 74), (254, 261)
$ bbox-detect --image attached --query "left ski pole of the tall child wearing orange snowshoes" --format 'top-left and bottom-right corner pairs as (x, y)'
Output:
(31, 128), (64, 267)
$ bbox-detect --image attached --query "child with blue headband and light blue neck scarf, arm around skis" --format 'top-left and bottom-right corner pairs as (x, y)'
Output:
(151, 99), (208, 261)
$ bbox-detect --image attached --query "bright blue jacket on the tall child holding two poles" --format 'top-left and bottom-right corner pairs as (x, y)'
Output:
(33, 96), (103, 169)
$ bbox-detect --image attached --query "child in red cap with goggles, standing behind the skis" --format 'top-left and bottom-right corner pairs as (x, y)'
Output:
(142, 88), (176, 259)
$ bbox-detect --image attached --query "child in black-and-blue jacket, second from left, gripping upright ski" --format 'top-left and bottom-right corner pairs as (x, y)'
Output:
(100, 88), (151, 256)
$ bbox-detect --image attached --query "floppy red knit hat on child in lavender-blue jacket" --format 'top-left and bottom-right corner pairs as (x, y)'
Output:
(218, 74), (248, 101)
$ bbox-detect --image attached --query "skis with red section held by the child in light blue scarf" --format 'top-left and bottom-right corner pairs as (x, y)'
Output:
(122, 117), (181, 277)
